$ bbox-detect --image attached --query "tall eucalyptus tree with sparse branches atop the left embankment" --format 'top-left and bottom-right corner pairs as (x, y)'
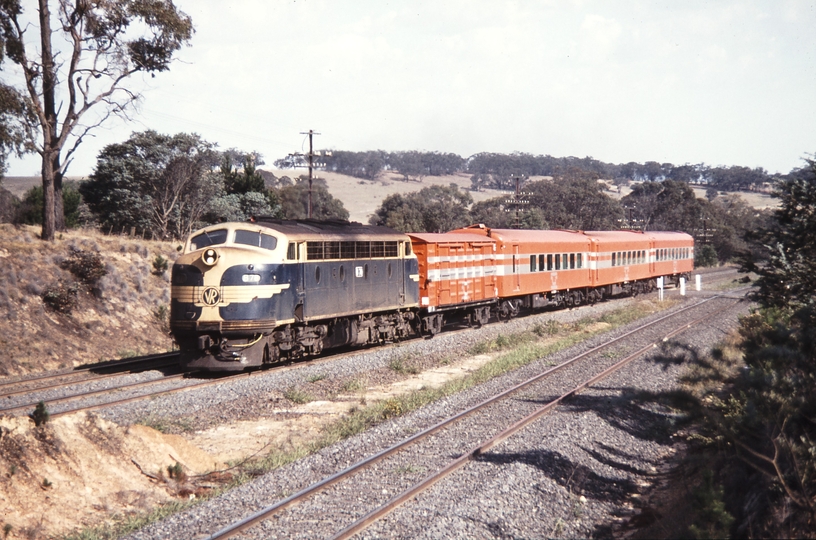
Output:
(0, 0), (193, 240)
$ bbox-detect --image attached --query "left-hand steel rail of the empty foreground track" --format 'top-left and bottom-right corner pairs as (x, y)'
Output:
(208, 296), (740, 540)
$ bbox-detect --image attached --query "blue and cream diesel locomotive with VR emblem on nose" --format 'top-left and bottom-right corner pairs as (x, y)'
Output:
(170, 218), (419, 371)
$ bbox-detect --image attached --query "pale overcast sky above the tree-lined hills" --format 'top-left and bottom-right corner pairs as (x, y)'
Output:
(7, 0), (816, 176)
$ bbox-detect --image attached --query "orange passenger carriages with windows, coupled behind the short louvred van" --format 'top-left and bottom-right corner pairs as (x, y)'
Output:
(452, 225), (694, 317)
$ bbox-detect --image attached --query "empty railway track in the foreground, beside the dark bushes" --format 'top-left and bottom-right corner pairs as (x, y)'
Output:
(204, 291), (739, 540)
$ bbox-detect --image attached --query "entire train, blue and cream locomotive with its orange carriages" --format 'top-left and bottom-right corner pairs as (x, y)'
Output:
(170, 218), (694, 371)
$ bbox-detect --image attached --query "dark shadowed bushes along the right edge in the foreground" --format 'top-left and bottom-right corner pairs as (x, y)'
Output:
(664, 155), (816, 537)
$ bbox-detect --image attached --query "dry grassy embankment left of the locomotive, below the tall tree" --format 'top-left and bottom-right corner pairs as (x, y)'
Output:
(0, 224), (177, 376)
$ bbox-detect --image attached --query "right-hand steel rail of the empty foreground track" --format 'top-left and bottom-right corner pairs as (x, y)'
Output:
(331, 303), (736, 540)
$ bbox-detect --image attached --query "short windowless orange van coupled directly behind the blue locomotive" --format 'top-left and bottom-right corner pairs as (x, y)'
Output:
(408, 232), (499, 333)
